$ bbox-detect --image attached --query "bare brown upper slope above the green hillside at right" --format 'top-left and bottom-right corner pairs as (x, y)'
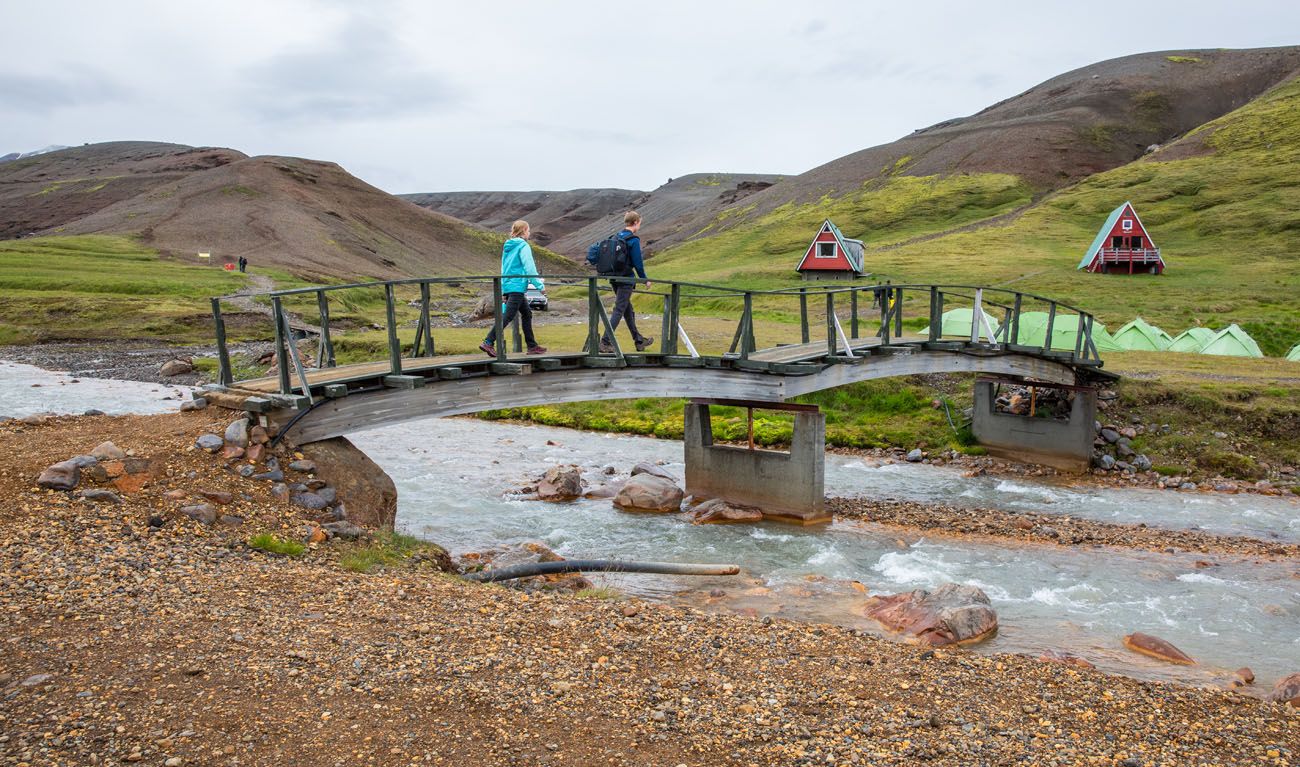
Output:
(639, 46), (1300, 250)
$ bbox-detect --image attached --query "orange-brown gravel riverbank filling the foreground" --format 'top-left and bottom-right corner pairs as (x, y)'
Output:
(0, 412), (1300, 767)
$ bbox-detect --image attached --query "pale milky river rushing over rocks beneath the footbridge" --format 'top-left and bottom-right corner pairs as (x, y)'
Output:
(0, 363), (1300, 689)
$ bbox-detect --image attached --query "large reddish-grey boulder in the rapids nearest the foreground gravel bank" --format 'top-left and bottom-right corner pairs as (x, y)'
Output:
(866, 584), (997, 646)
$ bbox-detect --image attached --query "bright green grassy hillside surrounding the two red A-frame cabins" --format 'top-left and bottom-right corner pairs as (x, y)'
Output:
(653, 79), (1300, 355)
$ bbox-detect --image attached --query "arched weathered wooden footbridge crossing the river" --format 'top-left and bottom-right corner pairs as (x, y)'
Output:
(209, 276), (1102, 443)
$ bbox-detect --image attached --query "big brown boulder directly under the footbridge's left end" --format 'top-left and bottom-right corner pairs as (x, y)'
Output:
(299, 437), (398, 529)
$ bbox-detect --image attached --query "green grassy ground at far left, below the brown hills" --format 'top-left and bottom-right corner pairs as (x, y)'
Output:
(0, 235), (247, 343)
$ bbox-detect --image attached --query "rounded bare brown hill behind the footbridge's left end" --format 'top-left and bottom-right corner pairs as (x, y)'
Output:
(43, 156), (512, 278)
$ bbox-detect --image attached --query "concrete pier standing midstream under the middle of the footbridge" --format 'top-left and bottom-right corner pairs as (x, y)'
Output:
(685, 400), (831, 525)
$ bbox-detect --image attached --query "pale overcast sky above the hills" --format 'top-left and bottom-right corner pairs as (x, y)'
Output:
(0, 0), (1300, 192)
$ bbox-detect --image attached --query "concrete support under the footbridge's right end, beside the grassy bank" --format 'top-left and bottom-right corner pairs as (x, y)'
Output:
(971, 381), (1097, 473)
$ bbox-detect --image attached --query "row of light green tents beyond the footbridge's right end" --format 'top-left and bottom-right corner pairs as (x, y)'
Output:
(920, 308), (1284, 361)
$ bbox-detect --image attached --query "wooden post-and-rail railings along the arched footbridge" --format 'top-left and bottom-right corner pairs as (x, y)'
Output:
(212, 274), (1100, 398)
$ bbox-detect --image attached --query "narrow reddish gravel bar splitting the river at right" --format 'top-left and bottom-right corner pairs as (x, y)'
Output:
(827, 498), (1300, 567)
